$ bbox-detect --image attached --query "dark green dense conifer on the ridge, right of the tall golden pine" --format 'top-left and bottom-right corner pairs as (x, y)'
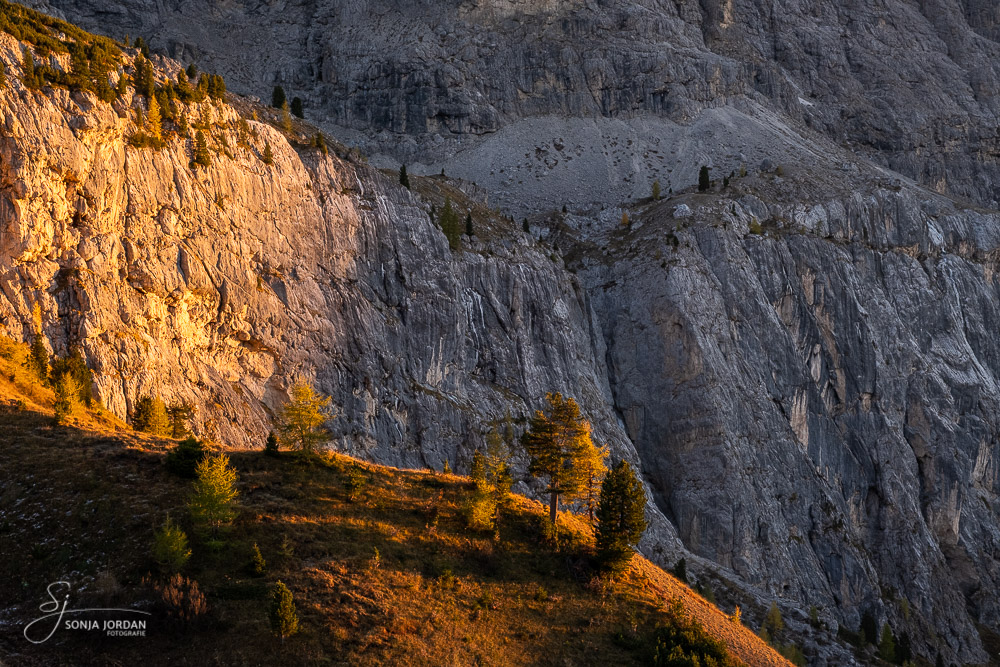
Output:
(597, 460), (646, 573)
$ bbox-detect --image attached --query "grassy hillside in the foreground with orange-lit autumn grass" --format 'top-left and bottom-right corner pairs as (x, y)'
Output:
(0, 345), (787, 665)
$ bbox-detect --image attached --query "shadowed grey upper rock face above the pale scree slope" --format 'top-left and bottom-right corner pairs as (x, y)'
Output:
(21, 0), (1000, 205)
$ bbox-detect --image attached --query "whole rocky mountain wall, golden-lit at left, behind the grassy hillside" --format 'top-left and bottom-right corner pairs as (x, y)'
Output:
(0, 2), (1000, 664)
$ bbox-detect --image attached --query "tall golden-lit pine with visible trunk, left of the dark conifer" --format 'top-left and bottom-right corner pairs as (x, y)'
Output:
(521, 393), (593, 525)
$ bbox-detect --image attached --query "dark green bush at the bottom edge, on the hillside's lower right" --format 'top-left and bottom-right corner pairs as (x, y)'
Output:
(647, 602), (735, 667)
